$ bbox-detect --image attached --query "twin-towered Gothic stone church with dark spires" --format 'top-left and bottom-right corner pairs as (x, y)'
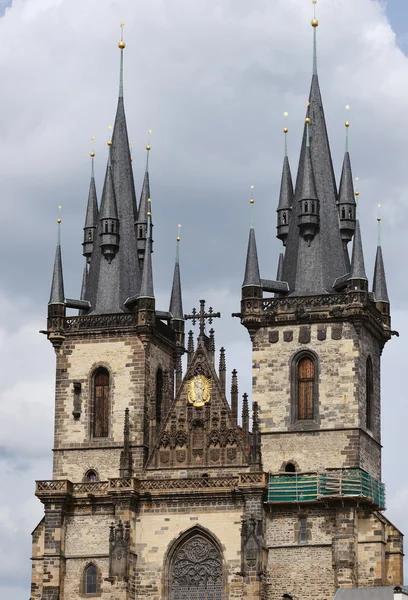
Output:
(31, 20), (403, 600)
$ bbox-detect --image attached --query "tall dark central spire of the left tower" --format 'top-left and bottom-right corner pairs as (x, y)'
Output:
(86, 31), (141, 314)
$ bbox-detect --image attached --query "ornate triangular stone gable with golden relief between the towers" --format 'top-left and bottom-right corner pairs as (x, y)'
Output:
(146, 338), (249, 470)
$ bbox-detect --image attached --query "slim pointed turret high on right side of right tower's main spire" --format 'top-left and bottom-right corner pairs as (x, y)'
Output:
(337, 121), (356, 252)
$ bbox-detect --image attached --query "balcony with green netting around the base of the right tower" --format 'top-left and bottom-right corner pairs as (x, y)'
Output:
(267, 469), (385, 510)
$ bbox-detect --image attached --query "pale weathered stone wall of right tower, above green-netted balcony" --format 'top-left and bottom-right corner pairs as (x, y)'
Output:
(252, 323), (381, 478)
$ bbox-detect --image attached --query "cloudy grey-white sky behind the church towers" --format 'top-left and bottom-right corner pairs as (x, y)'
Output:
(0, 0), (408, 600)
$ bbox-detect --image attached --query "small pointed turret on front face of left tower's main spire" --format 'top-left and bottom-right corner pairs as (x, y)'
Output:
(99, 152), (119, 263)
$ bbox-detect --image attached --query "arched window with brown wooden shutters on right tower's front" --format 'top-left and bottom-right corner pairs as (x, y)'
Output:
(293, 352), (318, 422)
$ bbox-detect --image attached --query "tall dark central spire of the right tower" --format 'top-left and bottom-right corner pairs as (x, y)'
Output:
(283, 19), (348, 296)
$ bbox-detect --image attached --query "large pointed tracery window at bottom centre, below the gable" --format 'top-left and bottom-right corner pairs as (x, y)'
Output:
(169, 533), (222, 600)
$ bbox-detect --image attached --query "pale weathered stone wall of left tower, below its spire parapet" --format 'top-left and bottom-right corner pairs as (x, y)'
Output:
(54, 335), (174, 481)
